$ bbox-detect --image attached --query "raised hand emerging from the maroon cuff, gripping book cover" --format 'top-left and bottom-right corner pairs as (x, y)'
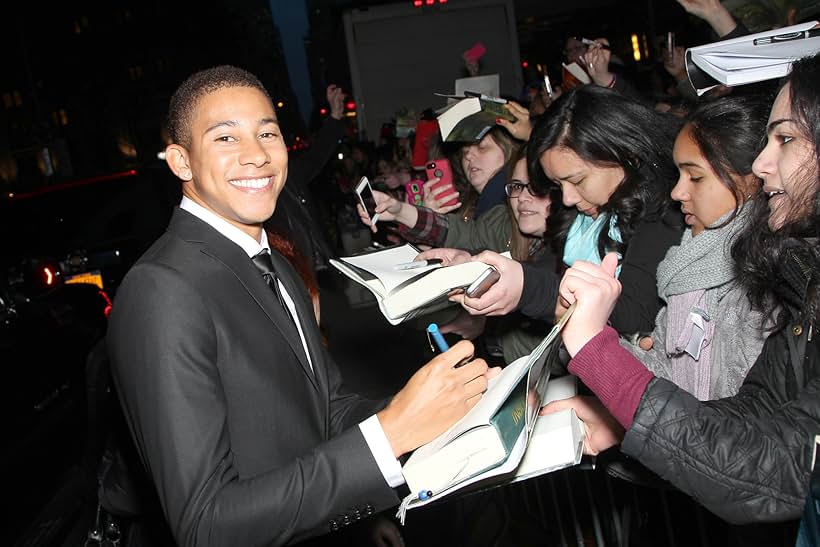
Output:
(558, 253), (621, 357)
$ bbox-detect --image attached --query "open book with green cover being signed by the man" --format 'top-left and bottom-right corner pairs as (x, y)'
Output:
(399, 308), (583, 519)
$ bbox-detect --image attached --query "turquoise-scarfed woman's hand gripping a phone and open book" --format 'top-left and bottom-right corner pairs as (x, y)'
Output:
(450, 251), (524, 315)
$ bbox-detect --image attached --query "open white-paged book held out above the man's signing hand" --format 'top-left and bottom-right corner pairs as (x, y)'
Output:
(330, 243), (494, 325)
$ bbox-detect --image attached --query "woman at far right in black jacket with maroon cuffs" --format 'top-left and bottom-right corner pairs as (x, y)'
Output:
(544, 55), (820, 532)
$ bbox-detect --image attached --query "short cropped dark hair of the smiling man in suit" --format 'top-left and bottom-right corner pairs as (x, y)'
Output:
(168, 65), (273, 147)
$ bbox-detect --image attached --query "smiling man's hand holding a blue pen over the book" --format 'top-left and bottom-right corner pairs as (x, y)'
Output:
(377, 340), (500, 458)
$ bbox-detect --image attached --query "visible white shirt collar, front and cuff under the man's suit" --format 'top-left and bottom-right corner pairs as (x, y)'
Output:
(179, 196), (404, 488)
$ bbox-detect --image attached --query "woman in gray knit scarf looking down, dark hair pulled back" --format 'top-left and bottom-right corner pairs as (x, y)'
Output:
(623, 97), (771, 400)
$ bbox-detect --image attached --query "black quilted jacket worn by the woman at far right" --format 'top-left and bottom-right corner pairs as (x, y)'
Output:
(621, 246), (820, 524)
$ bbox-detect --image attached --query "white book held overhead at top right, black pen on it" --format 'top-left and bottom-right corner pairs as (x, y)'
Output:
(686, 21), (820, 95)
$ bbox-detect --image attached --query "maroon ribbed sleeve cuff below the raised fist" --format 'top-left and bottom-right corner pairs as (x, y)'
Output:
(568, 327), (655, 429)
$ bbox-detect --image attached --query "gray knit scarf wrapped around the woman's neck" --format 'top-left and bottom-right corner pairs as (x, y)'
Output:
(657, 207), (749, 302)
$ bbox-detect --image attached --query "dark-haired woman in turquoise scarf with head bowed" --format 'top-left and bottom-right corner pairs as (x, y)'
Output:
(452, 86), (683, 336)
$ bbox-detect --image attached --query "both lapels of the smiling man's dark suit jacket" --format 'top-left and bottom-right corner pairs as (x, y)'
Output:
(168, 209), (319, 389)
